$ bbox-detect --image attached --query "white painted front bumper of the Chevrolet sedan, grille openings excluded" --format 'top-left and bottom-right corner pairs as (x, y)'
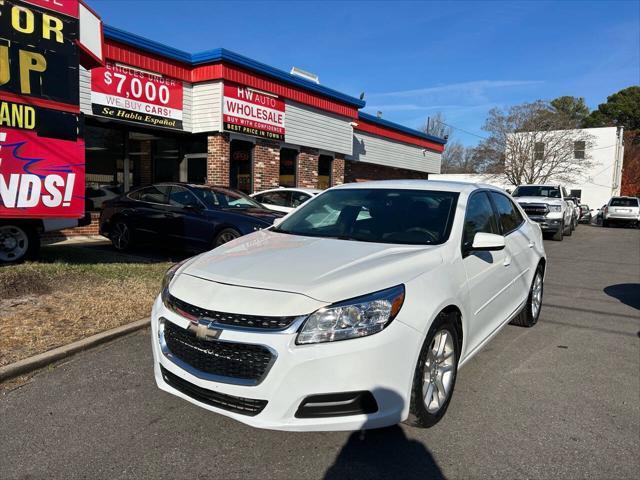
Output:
(151, 298), (424, 431)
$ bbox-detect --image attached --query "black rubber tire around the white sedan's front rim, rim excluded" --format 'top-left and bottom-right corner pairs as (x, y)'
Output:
(407, 313), (460, 428)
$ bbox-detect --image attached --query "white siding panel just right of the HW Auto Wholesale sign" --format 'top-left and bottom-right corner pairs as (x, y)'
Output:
(285, 100), (353, 155)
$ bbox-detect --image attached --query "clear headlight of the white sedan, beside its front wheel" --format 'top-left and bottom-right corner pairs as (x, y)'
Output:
(296, 285), (404, 345)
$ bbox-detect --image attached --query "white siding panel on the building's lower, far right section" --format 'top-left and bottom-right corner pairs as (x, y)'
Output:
(348, 131), (441, 173)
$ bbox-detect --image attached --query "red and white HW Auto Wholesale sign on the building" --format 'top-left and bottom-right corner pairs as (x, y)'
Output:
(222, 82), (285, 141)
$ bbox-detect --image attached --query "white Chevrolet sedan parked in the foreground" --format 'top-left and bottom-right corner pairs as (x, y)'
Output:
(152, 180), (546, 431)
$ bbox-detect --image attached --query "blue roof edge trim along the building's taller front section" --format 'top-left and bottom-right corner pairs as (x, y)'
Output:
(104, 25), (366, 108)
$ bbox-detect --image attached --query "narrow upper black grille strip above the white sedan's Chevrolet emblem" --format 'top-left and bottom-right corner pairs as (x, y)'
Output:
(166, 294), (298, 330)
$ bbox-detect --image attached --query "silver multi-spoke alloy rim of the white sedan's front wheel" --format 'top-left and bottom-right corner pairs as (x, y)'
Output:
(422, 329), (456, 414)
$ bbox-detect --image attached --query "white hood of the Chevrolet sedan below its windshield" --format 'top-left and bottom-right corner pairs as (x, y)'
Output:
(181, 230), (442, 303)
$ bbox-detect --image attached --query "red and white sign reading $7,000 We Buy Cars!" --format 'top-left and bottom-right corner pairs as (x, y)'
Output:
(91, 63), (183, 129)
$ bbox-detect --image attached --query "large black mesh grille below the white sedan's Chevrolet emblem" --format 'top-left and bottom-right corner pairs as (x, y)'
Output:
(164, 321), (274, 384)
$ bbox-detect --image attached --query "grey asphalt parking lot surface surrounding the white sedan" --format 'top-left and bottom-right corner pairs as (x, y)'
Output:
(0, 226), (640, 479)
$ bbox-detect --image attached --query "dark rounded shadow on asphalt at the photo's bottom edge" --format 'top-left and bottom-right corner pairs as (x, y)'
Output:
(324, 425), (445, 480)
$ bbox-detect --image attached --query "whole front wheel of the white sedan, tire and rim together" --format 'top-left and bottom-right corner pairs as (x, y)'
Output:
(405, 313), (460, 428)
